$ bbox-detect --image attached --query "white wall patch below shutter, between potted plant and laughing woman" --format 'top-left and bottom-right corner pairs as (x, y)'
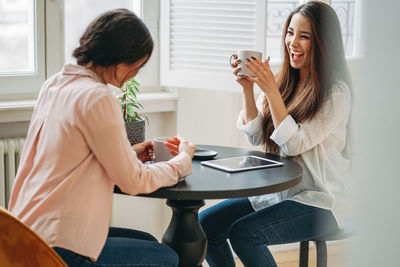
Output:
(177, 88), (242, 146)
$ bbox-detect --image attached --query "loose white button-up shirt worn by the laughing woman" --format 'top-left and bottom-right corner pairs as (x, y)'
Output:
(237, 81), (351, 227)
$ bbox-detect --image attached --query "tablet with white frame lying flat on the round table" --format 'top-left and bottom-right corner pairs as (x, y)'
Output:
(201, 156), (283, 172)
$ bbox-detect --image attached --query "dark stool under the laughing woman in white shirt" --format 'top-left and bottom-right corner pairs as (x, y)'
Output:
(299, 228), (353, 267)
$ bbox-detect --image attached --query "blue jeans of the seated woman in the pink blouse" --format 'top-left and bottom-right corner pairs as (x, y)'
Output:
(53, 227), (179, 267)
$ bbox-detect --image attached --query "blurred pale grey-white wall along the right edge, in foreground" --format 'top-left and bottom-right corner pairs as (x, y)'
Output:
(351, 0), (400, 267)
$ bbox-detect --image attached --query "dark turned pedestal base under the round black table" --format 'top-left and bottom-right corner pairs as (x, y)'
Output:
(162, 199), (207, 267)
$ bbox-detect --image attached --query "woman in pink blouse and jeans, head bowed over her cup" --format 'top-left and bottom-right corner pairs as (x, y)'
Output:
(9, 9), (195, 266)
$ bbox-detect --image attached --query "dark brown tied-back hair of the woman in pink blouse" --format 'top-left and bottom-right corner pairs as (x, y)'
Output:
(72, 9), (153, 67)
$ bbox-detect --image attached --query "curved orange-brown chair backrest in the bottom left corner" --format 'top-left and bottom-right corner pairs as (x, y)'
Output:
(0, 207), (67, 267)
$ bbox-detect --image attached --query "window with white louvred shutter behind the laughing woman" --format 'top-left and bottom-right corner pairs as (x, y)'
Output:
(160, 0), (356, 91)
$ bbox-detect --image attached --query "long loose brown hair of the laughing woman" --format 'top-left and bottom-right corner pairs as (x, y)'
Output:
(263, 1), (351, 154)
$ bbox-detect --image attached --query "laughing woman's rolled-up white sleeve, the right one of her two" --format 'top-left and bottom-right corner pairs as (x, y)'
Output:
(270, 82), (351, 156)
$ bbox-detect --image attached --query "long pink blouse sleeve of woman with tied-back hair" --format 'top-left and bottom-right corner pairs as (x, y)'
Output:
(80, 93), (192, 195)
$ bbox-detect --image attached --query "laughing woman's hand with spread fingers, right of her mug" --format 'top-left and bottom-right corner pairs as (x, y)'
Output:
(246, 57), (278, 96)
